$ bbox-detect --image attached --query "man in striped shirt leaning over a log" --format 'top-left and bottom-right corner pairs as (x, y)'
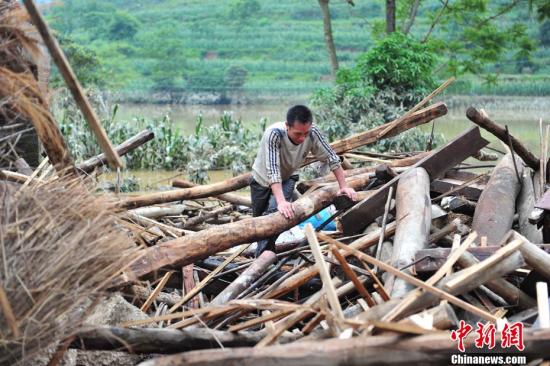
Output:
(250, 105), (357, 256)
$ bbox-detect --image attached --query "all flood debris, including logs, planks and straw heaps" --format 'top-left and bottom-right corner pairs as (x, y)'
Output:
(0, 1), (550, 365)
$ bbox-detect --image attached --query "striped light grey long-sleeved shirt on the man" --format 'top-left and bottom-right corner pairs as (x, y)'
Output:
(252, 122), (340, 187)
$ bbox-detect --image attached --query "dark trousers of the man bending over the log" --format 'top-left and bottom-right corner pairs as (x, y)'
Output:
(250, 175), (299, 257)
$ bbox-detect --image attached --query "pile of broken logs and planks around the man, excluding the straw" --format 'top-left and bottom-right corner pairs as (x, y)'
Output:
(8, 103), (550, 365)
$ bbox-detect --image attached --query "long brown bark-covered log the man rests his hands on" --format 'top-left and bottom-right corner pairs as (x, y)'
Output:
(114, 175), (369, 284)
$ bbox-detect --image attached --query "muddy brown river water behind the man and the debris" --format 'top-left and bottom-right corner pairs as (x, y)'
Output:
(112, 96), (550, 188)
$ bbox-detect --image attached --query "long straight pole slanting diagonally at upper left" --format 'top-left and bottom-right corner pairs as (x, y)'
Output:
(23, 0), (122, 168)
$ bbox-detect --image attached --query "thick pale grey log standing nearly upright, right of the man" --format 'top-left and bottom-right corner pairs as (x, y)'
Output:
(385, 168), (432, 297)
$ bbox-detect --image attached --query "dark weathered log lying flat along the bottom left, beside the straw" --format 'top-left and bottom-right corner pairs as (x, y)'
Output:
(70, 327), (296, 354)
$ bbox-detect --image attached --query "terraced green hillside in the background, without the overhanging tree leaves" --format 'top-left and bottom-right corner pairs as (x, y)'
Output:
(44, 0), (550, 100)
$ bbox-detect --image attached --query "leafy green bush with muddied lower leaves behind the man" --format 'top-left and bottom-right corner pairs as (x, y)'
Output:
(312, 33), (442, 151)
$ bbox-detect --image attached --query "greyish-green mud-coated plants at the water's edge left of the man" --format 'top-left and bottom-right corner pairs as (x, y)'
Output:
(52, 90), (265, 183)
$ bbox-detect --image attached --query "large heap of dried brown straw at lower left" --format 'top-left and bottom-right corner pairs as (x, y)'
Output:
(0, 178), (141, 365)
